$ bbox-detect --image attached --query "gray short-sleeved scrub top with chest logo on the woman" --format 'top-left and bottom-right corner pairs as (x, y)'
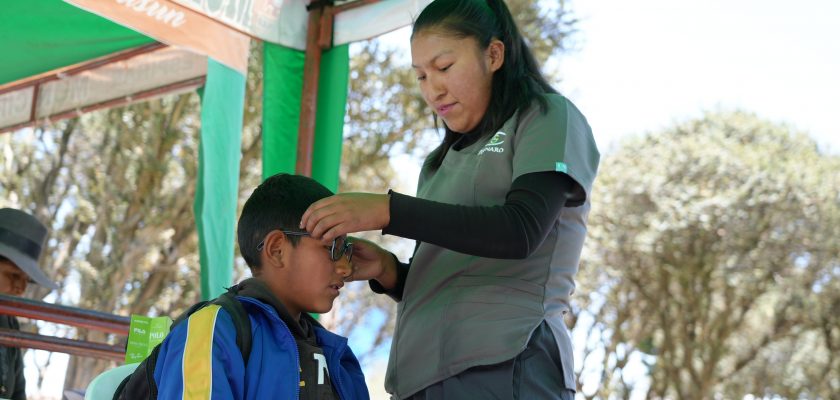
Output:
(385, 95), (599, 399)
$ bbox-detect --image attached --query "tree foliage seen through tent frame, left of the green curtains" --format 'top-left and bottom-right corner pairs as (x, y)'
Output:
(2, 95), (207, 387)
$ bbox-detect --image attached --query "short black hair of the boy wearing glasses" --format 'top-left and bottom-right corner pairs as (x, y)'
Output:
(237, 173), (333, 272)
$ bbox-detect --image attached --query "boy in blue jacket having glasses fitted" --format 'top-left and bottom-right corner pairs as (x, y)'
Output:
(154, 174), (369, 400)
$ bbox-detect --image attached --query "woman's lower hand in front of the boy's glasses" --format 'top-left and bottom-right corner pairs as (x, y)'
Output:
(347, 237), (397, 289)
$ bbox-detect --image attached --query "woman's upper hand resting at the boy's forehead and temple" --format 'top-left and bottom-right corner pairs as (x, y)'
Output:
(300, 193), (391, 241)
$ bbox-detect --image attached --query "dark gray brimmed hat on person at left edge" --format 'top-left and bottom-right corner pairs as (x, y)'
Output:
(0, 208), (58, 289)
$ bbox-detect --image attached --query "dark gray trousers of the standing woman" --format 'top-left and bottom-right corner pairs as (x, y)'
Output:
(409, 322), (575, 400)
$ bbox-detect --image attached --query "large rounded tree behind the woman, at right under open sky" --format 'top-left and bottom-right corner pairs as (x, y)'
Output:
(574, 112), (840, 399)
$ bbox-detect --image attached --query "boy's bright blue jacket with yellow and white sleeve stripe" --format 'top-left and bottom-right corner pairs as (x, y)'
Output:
(154, 296), (369, 400)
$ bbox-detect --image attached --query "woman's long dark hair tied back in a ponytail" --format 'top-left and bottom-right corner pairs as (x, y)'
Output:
(411, 0), (557, 169)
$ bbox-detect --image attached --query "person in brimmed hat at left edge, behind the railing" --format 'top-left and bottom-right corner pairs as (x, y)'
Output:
(0, 208), (58, 400)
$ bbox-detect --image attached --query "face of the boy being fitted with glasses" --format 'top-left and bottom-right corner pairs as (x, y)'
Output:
(270, 236), (352, 317)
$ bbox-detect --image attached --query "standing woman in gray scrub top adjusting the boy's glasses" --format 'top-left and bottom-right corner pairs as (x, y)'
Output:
(301, 0), (599, 399)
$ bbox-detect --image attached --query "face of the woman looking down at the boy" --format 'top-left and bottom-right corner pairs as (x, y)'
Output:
(411, 30), (504, 133)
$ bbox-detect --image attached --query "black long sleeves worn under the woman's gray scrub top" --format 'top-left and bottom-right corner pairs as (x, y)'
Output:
(370, 172), (585, 300)
